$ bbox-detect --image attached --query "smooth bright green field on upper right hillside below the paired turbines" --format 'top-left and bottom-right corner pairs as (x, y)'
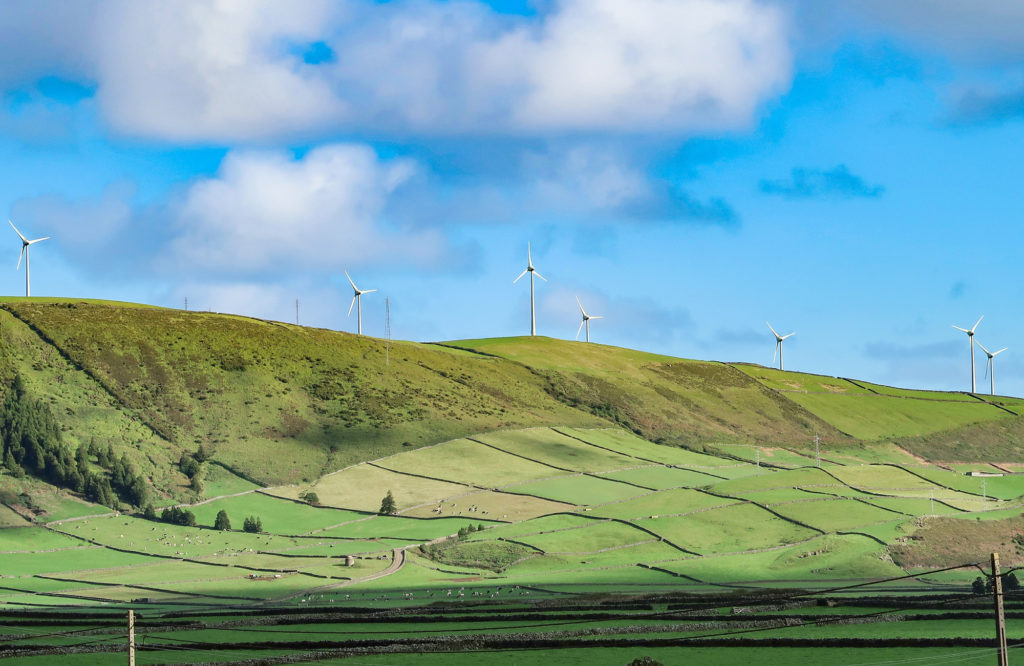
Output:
(786, 393), (1013, 440)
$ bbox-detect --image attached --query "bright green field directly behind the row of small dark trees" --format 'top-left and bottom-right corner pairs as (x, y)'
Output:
(186, 493), (366, 534)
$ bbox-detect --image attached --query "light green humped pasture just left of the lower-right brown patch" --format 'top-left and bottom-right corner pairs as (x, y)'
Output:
(657, 535), (903, 586)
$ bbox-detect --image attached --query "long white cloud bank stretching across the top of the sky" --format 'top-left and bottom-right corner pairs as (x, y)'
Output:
(0, 0), (791, 143)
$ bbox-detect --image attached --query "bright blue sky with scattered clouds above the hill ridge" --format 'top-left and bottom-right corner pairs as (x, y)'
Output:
(0, 0), (1024, 396)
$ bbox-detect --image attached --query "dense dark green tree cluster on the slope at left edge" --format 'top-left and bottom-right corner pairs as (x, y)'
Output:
(0, 375), (148, 508)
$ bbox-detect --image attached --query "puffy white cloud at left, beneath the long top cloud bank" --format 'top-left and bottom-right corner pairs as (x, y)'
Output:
(167, 144), (445, 274)
